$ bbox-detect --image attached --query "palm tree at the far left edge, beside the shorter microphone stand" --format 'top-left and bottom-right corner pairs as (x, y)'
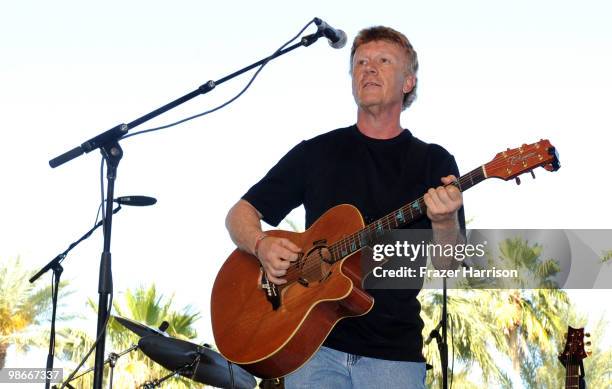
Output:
(0, 257), (67, 369)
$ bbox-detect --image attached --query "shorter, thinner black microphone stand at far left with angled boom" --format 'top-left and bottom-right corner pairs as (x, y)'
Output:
(29, 205), (121, 389)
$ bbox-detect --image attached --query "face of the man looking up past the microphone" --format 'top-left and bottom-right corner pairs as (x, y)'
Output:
(352, 41), (414, 108)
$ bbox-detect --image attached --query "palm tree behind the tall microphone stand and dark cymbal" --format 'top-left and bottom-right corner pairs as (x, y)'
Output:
(62, 284), (200, 389)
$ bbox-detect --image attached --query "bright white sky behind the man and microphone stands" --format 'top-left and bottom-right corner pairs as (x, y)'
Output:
(0, 0), (612, 376)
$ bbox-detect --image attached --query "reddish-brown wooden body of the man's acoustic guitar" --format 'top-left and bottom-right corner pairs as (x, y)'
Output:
(211, 204), (374, 378)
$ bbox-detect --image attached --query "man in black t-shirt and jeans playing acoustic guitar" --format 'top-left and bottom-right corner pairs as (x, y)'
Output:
(226, 27), (465, 389)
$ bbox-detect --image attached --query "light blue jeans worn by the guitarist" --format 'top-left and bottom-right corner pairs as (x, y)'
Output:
(285, 347), (425, 389)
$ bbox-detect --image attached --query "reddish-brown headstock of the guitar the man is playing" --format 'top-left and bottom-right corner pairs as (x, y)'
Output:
(484, 139), (561, 183)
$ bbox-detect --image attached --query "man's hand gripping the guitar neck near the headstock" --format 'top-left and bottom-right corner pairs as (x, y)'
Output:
(423, 175), (463, 227)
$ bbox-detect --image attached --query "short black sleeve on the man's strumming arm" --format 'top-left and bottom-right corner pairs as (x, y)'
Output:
(242, 141), (307, 226)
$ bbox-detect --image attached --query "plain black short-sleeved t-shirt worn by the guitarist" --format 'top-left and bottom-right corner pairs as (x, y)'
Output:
(243, 125), (465, 362)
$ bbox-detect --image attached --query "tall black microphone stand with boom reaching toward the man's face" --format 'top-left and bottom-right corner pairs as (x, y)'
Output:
(49, 20), (324, 389)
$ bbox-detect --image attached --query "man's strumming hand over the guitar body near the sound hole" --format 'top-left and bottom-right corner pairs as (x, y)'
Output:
(257, 236), (301, 285)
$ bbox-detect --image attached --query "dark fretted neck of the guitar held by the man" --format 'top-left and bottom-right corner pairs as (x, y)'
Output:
(329, 166), (487, 261)
